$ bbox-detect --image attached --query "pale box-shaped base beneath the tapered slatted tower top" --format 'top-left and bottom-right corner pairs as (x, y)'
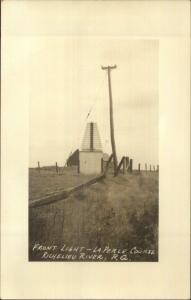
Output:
(80, 151), (103, 174)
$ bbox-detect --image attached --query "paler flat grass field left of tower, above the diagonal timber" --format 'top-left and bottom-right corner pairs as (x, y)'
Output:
(29, 167), (94, 200)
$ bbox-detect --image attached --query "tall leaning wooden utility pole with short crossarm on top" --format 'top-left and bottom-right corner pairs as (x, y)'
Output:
(101, 65), (118, 176)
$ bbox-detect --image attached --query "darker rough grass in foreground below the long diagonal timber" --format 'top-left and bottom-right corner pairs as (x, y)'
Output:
(29, 172), (158, 261)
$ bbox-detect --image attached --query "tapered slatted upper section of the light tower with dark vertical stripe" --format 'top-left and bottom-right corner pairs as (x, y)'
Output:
(81, 122), (102, 151)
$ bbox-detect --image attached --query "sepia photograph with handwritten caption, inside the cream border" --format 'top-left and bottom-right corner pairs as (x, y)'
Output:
(29, 37), (159, 262)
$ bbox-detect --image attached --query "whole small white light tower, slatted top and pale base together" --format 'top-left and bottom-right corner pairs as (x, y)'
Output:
(79, 122), (103, 174)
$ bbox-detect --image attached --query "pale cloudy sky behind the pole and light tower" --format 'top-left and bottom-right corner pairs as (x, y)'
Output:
(28, 35), (159, 167)
